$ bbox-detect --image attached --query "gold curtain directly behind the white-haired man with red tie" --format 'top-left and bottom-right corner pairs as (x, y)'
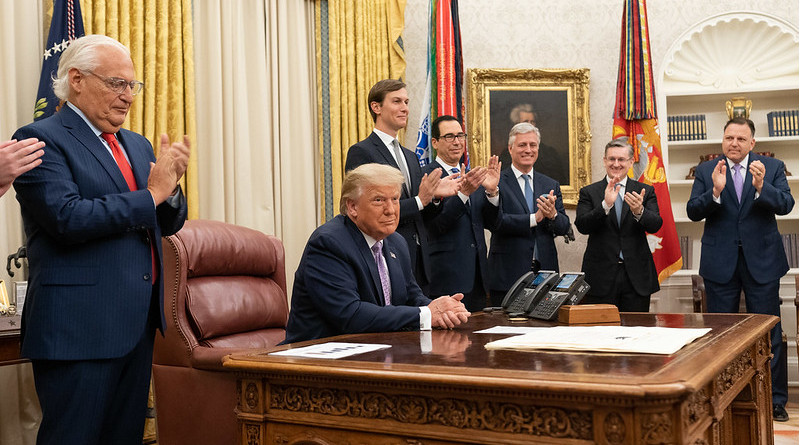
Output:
(78, 0), (198, 219)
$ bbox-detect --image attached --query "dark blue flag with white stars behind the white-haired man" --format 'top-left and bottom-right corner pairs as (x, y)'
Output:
(33, 0), (83, 121)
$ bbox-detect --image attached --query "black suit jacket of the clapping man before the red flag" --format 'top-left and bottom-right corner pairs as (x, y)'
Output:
(575, 178), (663, 297)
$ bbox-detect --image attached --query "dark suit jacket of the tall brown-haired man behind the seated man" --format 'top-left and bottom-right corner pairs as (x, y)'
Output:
(344, 131), (438, 281)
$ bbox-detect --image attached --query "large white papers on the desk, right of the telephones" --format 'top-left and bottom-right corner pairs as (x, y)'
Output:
(486, 326), (711, 354)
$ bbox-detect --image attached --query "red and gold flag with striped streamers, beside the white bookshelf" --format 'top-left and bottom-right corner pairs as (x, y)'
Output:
(613, 0), (683, 282)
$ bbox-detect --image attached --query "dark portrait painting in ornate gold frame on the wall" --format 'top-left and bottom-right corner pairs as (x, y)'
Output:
(467, 68), (592, 207)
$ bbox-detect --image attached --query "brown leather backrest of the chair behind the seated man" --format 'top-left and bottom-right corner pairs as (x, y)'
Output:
(154, 220), (289, 369)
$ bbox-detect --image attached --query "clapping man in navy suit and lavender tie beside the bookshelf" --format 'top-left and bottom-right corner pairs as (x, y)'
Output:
(686, 118), (794, 421)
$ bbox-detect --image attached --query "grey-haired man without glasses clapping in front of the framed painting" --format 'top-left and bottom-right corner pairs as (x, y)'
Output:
(489, 122), (570, 306)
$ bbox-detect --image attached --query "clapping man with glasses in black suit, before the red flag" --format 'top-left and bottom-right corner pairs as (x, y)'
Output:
(575, 139), (663, 312)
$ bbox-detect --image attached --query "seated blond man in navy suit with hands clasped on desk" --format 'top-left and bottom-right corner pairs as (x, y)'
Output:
(286, 164), (470, 343)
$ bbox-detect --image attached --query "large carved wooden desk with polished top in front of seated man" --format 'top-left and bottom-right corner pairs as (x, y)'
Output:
(224, 314), (777, 445)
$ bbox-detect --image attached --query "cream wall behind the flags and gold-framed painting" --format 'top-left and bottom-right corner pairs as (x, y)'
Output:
(403, 0), (798, 270)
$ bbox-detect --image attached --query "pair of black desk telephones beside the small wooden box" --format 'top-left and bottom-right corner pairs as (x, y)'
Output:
(503, 270), (591, 320)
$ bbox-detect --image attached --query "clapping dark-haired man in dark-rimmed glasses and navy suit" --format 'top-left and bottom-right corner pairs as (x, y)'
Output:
(422, 115), (500, 312)
